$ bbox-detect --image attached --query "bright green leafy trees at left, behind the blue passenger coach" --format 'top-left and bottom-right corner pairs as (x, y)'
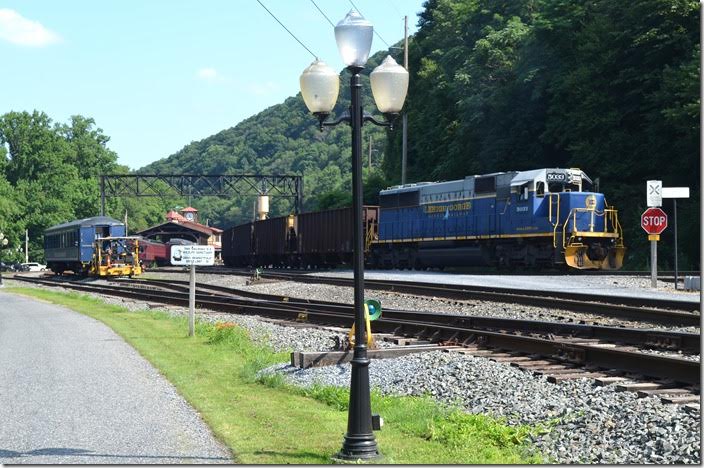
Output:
(0, 111), (175, 263)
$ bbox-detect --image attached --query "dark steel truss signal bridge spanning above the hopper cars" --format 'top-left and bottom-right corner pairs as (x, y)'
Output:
(100, 174), (303, 215)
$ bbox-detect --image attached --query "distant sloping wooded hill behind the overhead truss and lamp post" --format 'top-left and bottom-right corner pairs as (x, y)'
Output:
(139, 53), (396, 226)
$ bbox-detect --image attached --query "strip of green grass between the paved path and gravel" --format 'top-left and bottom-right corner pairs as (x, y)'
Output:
(5, 287), (544, 464)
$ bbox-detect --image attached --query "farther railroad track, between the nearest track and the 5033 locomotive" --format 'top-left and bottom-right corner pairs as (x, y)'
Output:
(144, 270), (701, 327)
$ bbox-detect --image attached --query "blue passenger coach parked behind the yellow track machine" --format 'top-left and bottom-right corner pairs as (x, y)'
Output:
(44, 216), (125, 274)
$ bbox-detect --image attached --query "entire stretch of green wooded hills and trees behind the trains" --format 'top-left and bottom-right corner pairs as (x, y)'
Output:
(0, 0), (700, 268)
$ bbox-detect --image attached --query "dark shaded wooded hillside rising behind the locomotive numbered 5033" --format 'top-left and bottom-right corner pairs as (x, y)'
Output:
(384, 0), (700, 268)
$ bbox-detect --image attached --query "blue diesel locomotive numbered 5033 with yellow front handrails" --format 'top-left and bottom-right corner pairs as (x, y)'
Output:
(367, 169), (625, 270)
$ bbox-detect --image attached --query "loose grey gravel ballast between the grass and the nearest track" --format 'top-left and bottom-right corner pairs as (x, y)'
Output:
(8, 275), (701, 464)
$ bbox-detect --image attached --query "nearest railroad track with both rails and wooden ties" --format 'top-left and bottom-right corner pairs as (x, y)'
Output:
(11, 278), (700, 403)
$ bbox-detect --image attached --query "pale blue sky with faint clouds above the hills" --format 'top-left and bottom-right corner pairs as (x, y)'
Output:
(0, 0), (424, 169)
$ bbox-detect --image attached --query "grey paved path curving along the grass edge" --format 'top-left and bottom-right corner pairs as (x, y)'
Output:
(0, 290), (232, 465)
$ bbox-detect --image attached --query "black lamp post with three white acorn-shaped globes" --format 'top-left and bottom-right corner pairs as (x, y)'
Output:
(300, 10), (408, 460)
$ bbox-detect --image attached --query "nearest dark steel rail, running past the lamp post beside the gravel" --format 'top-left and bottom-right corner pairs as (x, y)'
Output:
(15, 278), (700, 385)
